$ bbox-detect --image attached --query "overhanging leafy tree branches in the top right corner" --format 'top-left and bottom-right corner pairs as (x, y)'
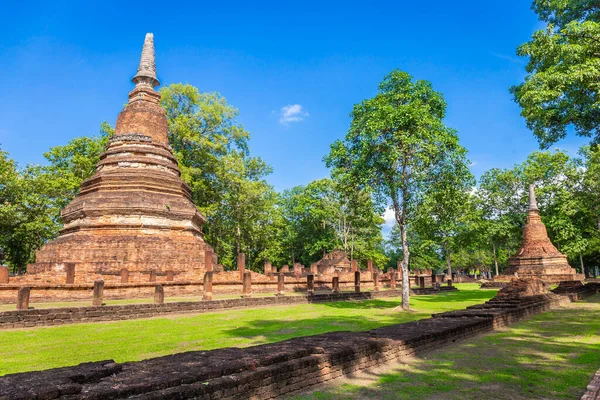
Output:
(511, 0), (600, 148)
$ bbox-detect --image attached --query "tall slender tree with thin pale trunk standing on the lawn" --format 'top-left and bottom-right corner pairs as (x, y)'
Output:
(326, 70), (464, 309)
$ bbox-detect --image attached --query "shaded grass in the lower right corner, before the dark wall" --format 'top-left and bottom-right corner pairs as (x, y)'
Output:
(296, 295), (600, 400)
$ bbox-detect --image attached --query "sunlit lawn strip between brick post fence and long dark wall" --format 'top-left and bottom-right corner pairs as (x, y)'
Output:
(0, 284), (495, 375)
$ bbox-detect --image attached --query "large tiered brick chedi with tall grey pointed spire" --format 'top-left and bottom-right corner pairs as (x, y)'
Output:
(27, 33), (212, 283)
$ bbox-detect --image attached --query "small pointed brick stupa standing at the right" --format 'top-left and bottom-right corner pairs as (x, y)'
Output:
(494, 185), (584, 283)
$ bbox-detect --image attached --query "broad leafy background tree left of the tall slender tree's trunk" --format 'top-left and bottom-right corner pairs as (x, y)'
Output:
(277, 179), (387, 268)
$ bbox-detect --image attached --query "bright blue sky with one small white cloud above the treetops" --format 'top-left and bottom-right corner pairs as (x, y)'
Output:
(0, 0), (586, 216)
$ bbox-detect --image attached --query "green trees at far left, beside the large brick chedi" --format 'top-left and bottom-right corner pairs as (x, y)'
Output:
(0, 123), (112, 272)
